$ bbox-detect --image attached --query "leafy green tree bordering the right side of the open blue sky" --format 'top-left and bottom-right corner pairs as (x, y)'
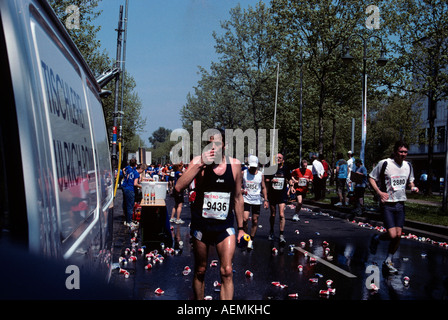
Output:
(181, 1), (277, 154)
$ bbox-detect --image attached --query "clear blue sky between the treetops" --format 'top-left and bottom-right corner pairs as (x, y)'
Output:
(94, 0), (259, 145)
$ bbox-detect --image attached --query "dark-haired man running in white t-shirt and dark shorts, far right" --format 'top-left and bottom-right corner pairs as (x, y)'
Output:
(369, 141), (418, 274)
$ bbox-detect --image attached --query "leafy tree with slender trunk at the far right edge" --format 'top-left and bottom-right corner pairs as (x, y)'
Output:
(386, 0), (448, 194)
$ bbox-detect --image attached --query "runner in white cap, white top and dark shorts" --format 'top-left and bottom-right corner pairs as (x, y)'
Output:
(243, 156), (269, 249)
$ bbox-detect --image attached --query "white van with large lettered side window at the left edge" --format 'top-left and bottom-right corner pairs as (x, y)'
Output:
(0, 0), (113, 292)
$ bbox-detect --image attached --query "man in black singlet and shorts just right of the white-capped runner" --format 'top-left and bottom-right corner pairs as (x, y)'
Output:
(265, 153), (291, 245)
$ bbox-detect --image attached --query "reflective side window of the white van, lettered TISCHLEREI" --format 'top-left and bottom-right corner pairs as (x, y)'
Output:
(31, 10), (97, 240)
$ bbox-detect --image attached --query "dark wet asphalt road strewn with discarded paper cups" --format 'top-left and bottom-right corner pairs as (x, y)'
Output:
(111, 191), (448, 300)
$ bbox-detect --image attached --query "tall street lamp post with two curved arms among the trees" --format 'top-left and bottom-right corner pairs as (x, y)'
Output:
(342, 34), (387, 165)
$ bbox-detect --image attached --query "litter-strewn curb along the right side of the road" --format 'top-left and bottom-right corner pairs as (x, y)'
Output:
(303, 199), (448, 241)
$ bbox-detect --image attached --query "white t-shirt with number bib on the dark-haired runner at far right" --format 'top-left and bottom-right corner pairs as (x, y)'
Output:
(369, 159), (414, 202)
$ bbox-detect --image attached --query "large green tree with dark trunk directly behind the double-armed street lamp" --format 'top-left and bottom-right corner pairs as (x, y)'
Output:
(272, 0), (382, 159)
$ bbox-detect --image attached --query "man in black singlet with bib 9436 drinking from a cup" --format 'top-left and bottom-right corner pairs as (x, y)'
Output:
(175, 130), (245, 300)
